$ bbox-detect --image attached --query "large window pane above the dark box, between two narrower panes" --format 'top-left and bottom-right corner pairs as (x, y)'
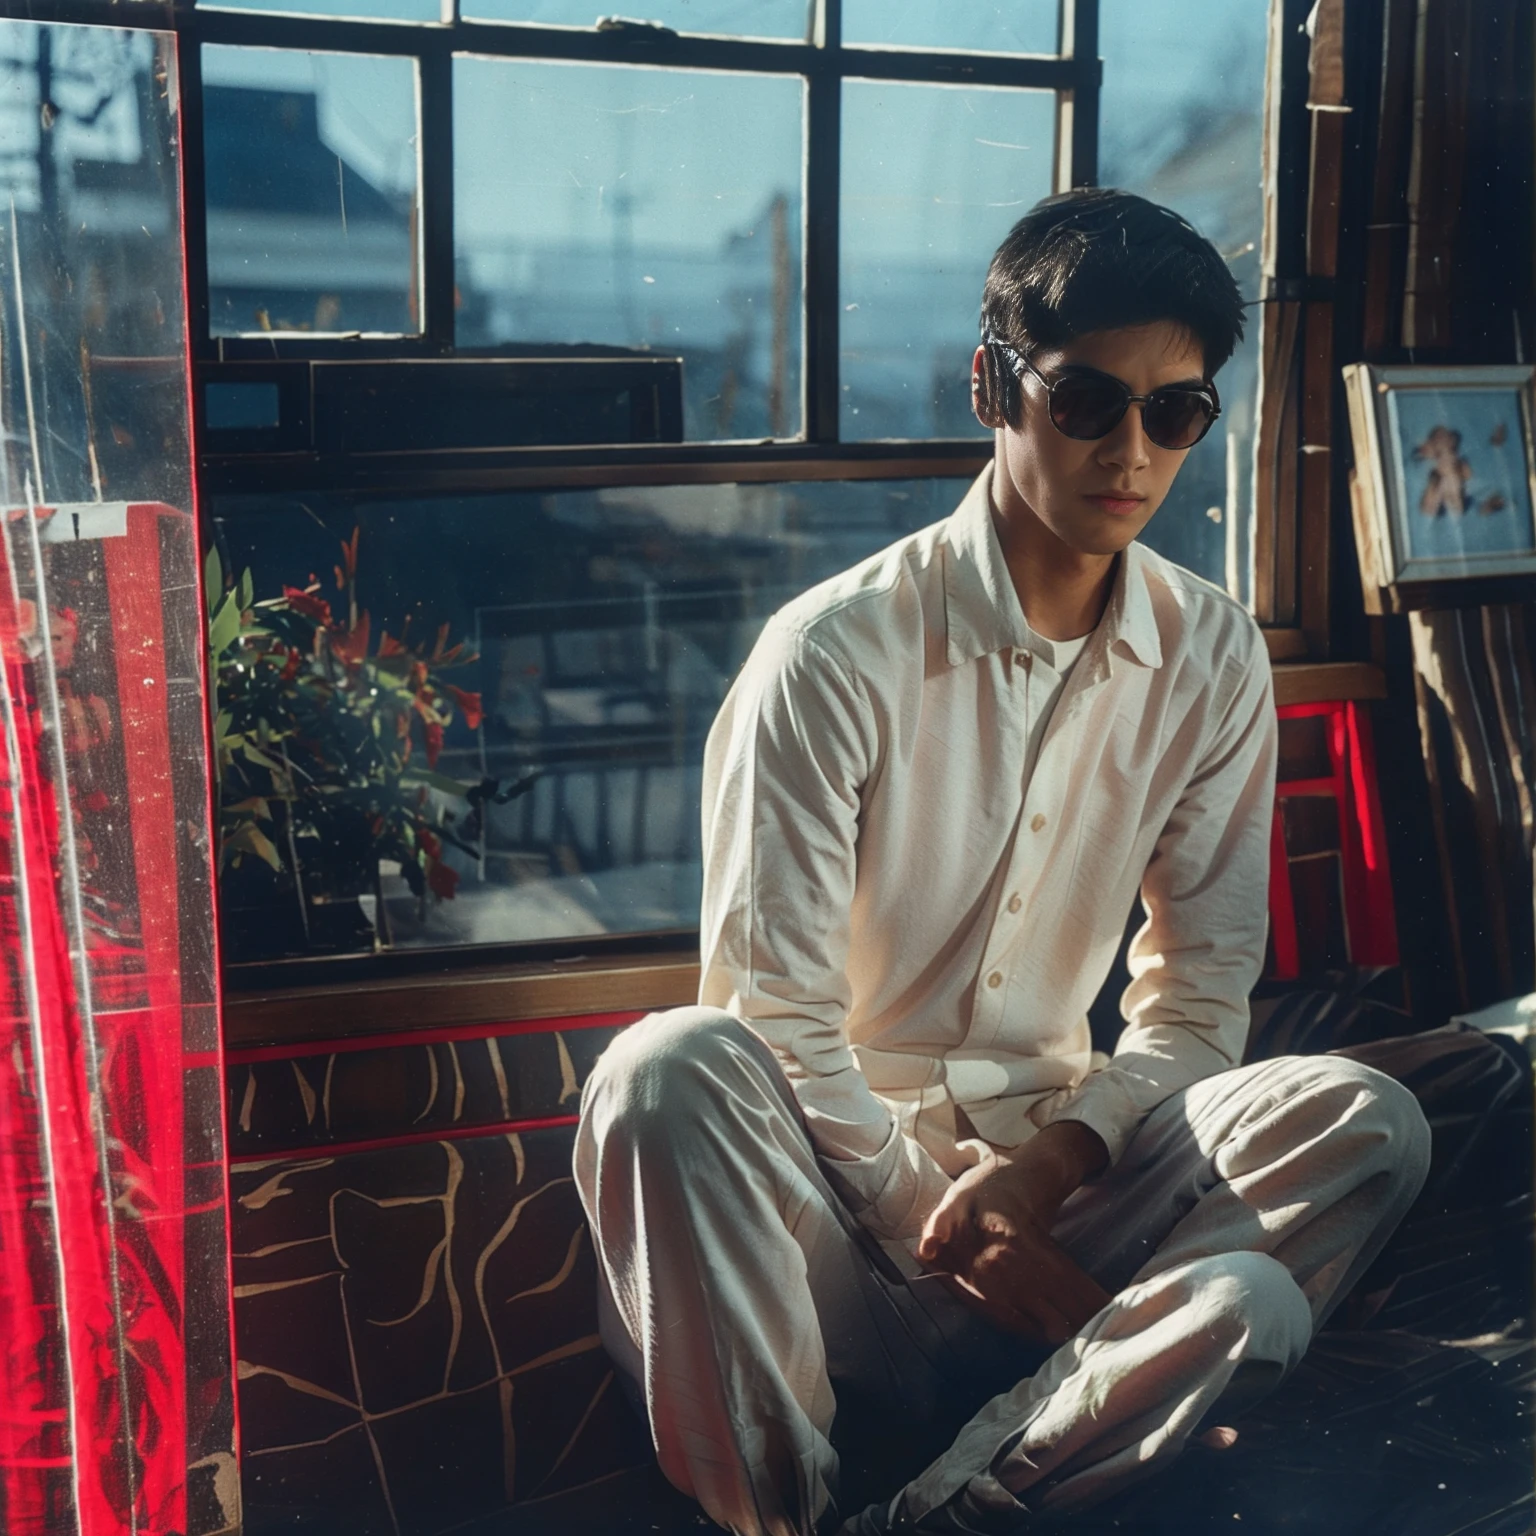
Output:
(453, 58), (803, 438)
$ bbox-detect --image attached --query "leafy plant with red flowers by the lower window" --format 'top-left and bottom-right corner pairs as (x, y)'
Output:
(204, 528), (488, 958)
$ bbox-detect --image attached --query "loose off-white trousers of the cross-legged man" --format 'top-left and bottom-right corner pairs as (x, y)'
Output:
(574, 1008), (1428, 1536)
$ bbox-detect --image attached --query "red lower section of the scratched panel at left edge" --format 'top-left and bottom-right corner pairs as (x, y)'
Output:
(0, 504), (235, 1536)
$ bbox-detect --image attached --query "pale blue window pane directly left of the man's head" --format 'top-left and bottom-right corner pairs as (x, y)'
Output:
(839, 80), (1055, 439)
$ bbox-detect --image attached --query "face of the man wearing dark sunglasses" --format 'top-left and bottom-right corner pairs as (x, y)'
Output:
(978, 321), (1204, 554)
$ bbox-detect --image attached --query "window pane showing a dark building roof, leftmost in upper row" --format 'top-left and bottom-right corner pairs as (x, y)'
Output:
(203, 45), (421, 336)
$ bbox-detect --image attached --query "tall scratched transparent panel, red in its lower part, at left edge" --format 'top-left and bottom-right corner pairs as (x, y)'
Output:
(0, 20), (240, 1536)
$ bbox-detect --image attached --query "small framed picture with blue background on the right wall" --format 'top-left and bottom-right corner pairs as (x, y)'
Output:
(1344, 362), (1536, 590)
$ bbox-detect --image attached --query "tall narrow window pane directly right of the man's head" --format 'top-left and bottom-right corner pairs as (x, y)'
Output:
(1098, 0), (1267, 601)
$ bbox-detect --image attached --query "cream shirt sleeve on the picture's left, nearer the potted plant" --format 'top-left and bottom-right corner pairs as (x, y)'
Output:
(699, 624), (949, 1238)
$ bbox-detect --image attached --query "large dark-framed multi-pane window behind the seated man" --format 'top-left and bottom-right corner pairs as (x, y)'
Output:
(6, 0), (1266, 963)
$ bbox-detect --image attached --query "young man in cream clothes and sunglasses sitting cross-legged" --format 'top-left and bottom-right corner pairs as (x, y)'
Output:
(576, 190), (1428, 1536)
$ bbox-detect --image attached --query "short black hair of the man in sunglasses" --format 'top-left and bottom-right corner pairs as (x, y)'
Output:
(982, 187), (1243, 419)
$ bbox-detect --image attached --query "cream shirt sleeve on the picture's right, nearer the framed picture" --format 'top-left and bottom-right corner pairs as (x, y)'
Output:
(1051, 623), (1278, 1164)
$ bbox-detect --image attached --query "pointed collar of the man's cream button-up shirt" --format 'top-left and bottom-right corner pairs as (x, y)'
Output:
(945, 464), (1163, 667)
